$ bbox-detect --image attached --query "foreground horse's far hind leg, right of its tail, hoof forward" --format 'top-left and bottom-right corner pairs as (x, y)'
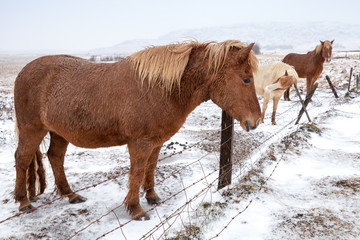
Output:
(47, 132), (86, 203)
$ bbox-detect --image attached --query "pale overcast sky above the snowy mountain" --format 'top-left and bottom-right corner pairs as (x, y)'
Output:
(0, 0), (360, 52)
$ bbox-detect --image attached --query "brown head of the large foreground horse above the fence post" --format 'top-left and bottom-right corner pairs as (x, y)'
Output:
(209, 43), (261, 131)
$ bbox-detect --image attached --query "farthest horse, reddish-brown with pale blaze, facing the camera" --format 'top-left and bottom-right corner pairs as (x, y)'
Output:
(283, 40), (334, 101)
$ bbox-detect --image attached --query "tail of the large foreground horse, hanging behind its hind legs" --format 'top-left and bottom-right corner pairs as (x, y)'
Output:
(15, 116), (46, 200)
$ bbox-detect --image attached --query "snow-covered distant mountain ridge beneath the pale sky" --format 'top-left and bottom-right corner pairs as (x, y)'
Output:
(90, 22), (360, 55)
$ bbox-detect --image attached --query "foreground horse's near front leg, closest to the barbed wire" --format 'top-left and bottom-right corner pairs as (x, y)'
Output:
(125, 141), (154, 220)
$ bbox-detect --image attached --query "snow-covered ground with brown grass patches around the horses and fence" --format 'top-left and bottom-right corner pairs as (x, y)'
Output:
(0, 56), (360, 239)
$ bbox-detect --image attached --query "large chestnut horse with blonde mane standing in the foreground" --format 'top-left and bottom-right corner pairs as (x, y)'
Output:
(14, 40), (261, 219)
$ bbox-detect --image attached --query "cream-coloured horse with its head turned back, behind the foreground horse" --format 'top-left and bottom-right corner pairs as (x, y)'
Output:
(254, 62), (299, 125)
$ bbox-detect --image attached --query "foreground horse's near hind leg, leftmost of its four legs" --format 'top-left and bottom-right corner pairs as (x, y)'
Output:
(14, 127), (47, 211)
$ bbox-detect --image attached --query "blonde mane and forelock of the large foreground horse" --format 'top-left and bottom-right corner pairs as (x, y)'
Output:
(128, 40), (258, 93)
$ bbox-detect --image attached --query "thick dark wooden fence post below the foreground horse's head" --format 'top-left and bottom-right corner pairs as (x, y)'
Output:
(218, 111), (234, 190)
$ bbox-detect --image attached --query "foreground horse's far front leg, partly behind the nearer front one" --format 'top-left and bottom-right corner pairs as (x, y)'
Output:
(143, 146), (161, 205)
